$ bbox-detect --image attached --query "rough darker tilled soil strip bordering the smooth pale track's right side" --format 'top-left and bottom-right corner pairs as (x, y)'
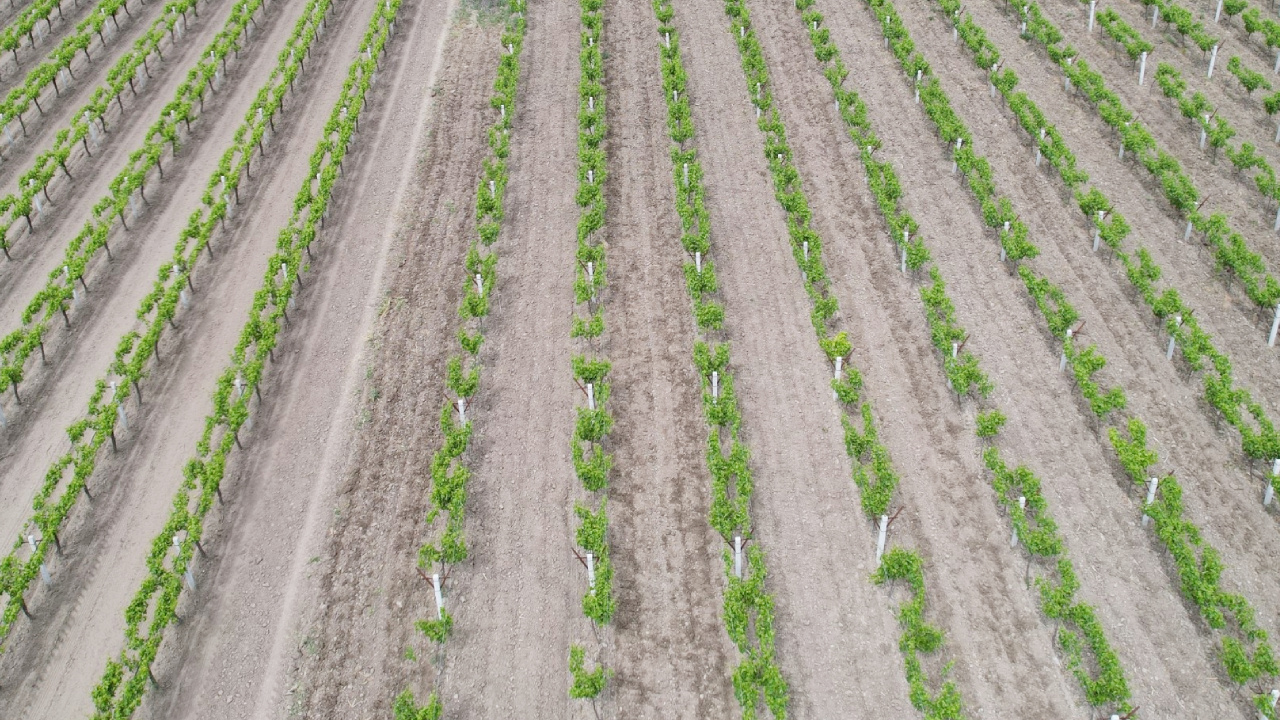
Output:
(282, 12), (500, 719)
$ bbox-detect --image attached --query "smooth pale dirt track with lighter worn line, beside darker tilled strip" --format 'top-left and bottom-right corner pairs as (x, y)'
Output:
(133, 1), (460, 717)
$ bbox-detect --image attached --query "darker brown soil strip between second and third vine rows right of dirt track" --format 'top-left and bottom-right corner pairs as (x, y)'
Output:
(593, 1), (737, 719)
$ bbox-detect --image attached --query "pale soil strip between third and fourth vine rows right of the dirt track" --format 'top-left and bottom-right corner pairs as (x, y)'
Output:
(676, 0), (914, 717)
